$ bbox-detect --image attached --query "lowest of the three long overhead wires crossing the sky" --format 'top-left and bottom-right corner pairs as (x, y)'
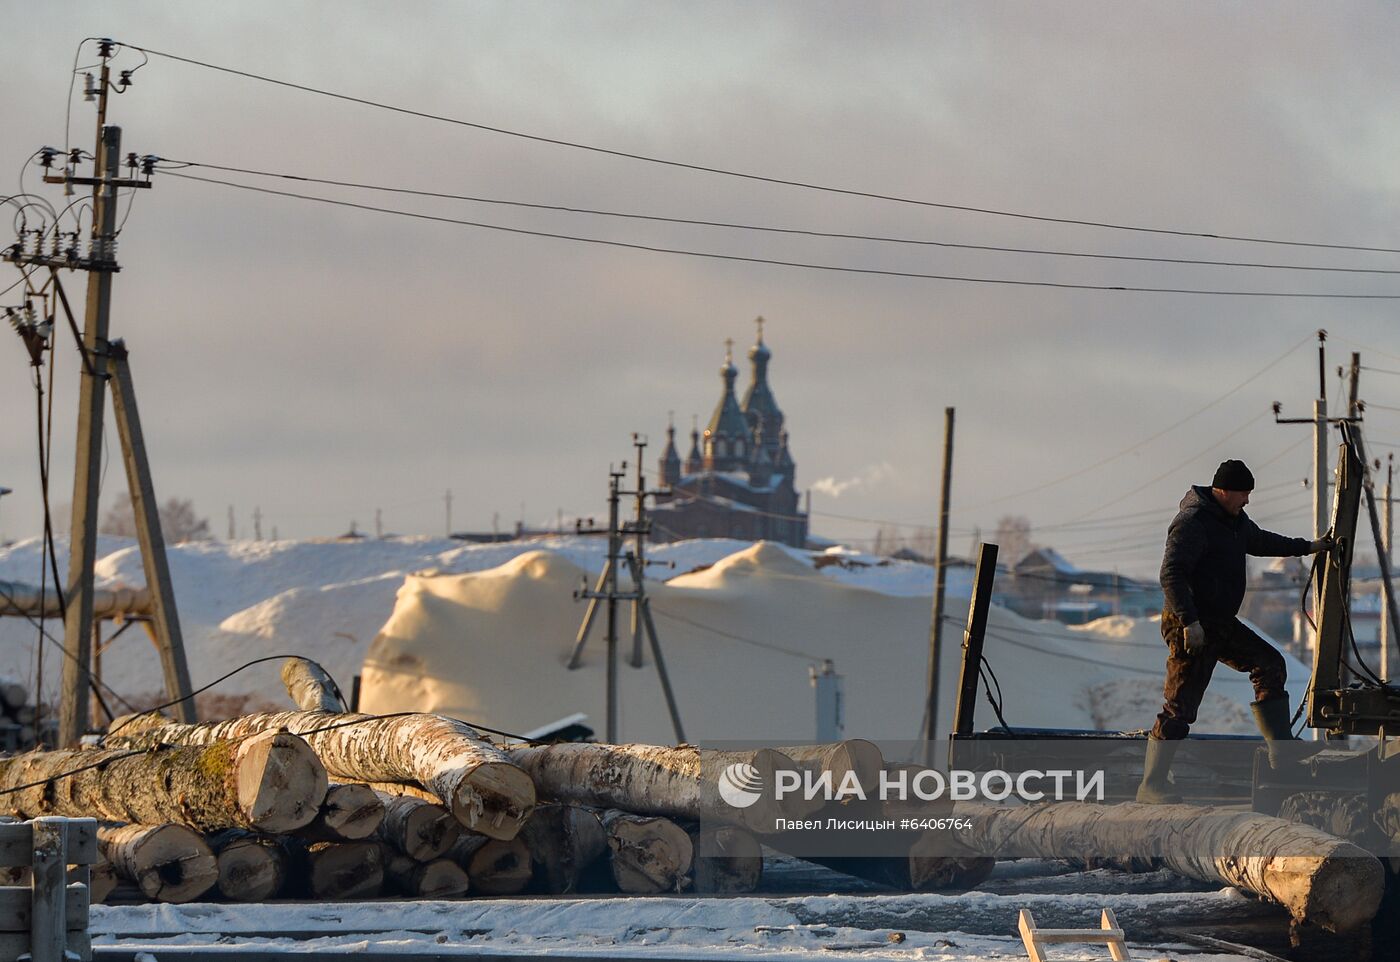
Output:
(165, 171), (1400, 301)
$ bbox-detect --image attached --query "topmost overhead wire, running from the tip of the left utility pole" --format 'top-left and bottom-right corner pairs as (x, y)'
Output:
(122, 43), (1400, 253)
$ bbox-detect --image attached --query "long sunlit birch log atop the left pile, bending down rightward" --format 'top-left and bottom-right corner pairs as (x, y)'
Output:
(109, 711), (535, 839)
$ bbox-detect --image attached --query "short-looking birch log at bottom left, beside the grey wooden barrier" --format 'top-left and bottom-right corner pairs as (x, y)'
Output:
(97, 825), (218, 902)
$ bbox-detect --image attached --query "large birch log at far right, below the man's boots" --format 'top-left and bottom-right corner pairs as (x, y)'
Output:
(956, 802), (1385, 933)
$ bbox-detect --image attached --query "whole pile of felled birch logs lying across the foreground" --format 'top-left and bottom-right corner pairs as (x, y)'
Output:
(0, 660), (1383, 930)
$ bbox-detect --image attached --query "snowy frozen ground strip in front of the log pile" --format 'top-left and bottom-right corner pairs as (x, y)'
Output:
(92, 860), (1260, 962)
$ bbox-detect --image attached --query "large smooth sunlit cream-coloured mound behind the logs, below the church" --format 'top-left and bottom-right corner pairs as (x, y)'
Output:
(361, 542), (1306, 744)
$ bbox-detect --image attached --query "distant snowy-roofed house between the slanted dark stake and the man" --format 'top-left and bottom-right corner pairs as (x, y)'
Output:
(1002, 548), (1162, 625)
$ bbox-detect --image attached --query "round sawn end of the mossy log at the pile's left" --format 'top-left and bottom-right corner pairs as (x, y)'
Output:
(234, 731), (326, 833)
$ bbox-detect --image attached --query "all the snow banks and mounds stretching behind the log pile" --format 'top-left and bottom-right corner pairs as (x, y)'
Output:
(0, 538), (1306, 741)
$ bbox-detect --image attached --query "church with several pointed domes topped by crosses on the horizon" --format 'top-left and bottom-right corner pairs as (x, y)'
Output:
(651, 318), (808, 548)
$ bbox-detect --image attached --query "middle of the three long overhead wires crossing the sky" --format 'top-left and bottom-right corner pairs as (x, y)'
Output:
(160, 158), (1400, 274)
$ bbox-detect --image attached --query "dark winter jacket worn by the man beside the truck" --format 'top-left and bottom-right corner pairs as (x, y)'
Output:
(1162, 485), (1312, 625)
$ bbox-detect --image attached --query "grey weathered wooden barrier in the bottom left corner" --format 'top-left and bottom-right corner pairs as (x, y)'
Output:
(0, 818), (98, 962)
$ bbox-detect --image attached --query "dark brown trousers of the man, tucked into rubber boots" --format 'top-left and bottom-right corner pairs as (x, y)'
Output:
(1152, 612), (1288, 739)
